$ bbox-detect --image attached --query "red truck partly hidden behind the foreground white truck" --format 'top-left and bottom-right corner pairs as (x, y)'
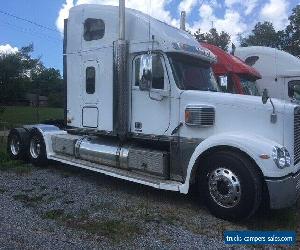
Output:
(201, 43), (261, 96)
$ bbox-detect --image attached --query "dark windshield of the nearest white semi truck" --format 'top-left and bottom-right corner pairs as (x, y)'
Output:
(168, 53), (218, 91)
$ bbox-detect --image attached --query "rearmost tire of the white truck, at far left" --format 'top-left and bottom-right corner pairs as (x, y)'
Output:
(7, 128), (29, 160)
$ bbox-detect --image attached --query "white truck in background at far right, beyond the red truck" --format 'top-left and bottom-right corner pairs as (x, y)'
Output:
(235, 46), (300, 101)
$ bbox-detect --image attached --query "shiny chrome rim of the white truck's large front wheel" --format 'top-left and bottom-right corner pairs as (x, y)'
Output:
(208, 168), (242, 208)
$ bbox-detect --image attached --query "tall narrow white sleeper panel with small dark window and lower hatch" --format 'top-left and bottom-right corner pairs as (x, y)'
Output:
(82, 61), (100, 128)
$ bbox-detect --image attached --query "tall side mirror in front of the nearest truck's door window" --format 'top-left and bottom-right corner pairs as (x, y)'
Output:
(139, 55), (152, 91)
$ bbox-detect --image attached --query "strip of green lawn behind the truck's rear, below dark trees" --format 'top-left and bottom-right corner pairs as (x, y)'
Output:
(0, 106), (64, 130)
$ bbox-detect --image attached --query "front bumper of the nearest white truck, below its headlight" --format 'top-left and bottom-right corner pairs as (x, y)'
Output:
(266, 171), (300, 209)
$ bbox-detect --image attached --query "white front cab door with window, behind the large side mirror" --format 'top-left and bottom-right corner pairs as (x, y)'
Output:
(131, 54), (170, 135)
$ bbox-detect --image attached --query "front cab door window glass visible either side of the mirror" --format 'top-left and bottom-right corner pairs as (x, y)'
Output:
(134, 54), (165, 89)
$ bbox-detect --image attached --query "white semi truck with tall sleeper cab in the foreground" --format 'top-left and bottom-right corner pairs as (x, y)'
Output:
(7, 1), (300, 219)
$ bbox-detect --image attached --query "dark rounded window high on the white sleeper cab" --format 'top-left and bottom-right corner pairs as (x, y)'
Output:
(83, 18), (105, 41)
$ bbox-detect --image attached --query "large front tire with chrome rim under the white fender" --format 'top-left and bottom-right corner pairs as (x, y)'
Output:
(198, 151), (262, 221)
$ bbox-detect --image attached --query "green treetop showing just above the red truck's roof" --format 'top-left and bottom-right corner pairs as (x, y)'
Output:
(194, 28), (231, 51)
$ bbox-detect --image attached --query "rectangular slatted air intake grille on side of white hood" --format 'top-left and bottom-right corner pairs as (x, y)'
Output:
(185, 106), (215, 127)
